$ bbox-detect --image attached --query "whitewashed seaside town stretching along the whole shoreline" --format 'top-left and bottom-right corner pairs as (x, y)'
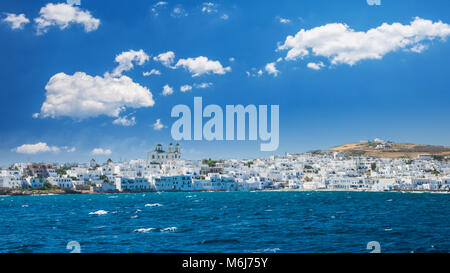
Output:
(0, 140), (450, 193)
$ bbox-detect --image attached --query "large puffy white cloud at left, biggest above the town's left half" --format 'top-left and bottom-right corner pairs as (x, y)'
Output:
(40, 72), (155, 119)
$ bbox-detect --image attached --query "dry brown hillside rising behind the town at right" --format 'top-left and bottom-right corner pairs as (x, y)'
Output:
(330, 142), (450, 158)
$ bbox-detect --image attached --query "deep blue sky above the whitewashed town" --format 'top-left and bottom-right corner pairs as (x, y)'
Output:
(0, 0), (450, 165)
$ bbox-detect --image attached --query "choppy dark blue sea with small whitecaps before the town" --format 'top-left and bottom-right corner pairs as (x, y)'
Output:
(0, 192), (450, 252)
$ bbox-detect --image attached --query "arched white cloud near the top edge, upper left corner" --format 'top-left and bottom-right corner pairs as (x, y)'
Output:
(34, 3), (100, 34)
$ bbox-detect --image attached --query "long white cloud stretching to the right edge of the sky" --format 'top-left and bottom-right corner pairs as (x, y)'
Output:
(278, 17), (450, 65)
